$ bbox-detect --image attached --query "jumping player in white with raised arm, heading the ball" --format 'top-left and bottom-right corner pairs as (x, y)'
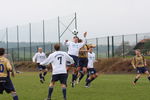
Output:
(65, 32), (87, 87)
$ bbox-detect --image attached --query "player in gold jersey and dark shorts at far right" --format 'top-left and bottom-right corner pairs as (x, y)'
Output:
(131, 49), (150, 85)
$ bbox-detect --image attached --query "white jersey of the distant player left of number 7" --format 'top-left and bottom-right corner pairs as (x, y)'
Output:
(32, 52), (46, 63)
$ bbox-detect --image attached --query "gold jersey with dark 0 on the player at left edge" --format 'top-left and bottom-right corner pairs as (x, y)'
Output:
(0, 56), (12, 77)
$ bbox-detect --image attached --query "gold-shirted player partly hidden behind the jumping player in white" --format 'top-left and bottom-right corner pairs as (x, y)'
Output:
(77, 39), (89, 84)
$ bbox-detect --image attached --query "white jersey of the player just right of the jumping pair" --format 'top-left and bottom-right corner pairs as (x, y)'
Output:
(87, 52), (96, 68)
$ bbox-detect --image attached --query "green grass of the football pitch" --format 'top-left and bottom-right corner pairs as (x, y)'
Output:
(0, 72), (150, 100)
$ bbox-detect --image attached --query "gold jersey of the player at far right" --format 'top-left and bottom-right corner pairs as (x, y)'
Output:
(131, 55), (146, 67)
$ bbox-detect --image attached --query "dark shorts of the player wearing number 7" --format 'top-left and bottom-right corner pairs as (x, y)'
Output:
(51, 74), (68, 85)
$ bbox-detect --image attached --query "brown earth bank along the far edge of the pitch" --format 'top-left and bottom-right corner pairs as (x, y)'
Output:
(14, 58), (150, 74)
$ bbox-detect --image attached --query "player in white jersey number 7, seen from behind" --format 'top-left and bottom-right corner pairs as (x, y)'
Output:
(40, 44), (74, 100)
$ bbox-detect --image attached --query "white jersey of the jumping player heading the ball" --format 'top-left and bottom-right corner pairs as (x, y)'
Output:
(65, 39), (86, 56)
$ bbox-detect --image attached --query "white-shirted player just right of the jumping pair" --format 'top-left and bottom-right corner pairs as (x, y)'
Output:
(85, 46), (98, 87)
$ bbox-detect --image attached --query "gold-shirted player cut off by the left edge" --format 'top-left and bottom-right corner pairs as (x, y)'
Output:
(0, 48), (19, 100)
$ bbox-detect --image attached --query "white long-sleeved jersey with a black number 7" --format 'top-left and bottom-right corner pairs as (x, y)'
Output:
(40, 51), (74, 75)
